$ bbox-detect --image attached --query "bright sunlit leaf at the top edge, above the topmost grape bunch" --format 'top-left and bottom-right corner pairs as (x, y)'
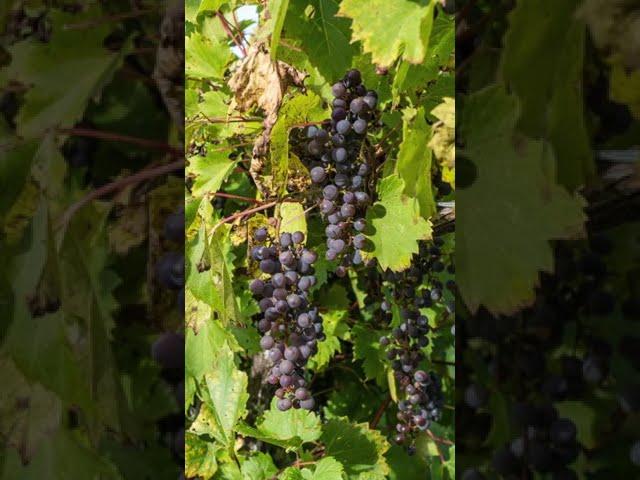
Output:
(338, 0), (435, 67)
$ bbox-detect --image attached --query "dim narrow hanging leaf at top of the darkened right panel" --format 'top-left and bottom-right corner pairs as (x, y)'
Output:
(501, 0), (595, 190)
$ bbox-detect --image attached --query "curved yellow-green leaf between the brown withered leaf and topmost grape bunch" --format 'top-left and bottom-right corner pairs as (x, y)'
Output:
(270, 92), (327, 194)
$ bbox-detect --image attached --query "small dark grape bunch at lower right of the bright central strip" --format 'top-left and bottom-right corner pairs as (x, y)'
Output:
(380, 310), (444, 454)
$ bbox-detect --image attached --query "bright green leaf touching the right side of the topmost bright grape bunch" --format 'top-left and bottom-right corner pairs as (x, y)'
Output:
(363, 175), (431, 271)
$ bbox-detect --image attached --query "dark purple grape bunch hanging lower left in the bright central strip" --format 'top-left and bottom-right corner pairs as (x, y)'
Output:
(249, 228), (324, 411)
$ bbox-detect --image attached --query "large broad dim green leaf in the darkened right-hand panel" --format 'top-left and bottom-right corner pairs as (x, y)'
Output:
(456, 86), (584, 313)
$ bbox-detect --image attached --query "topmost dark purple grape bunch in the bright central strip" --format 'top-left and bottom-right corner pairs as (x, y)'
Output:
(292, 70), (378, 277)
